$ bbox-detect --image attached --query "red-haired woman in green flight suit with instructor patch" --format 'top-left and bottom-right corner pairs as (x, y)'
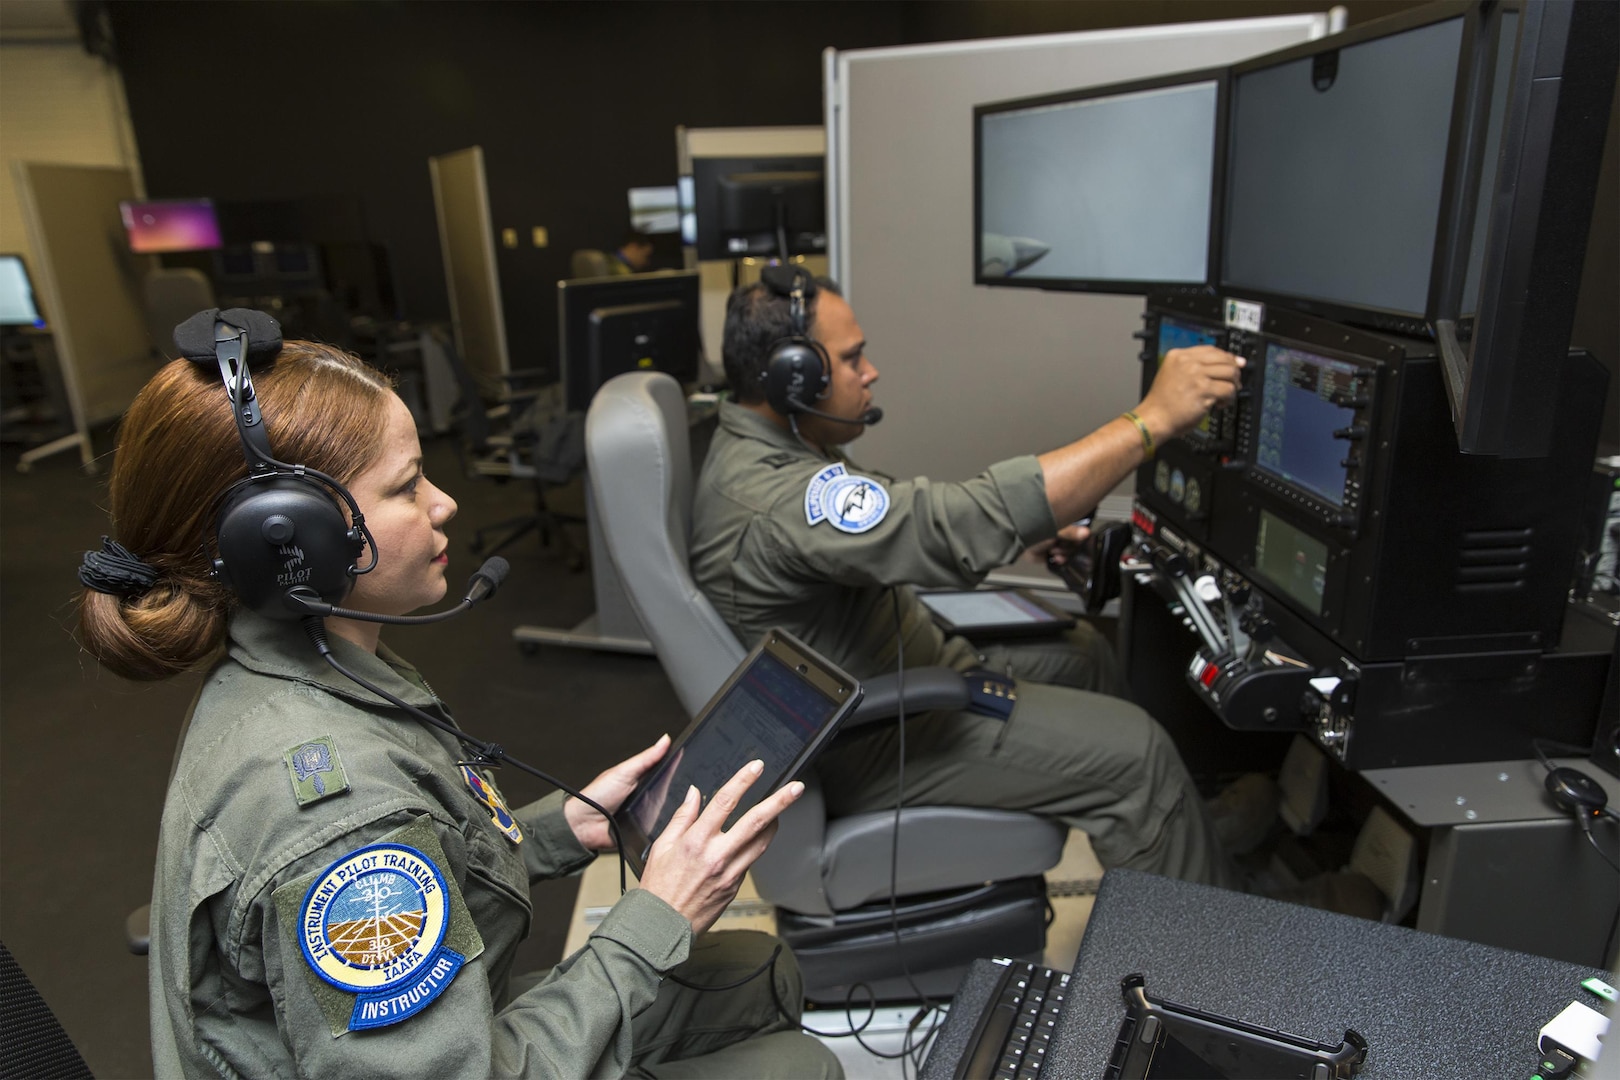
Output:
(79, 333), (839, 1077)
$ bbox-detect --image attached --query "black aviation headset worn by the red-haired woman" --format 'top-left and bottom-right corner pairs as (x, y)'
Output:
(175, 308), (377, 620)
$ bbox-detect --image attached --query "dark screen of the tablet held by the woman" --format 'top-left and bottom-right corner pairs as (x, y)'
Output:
(625, 653), (844, 840)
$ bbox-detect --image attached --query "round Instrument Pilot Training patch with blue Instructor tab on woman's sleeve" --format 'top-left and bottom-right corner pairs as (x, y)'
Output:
(274, 814), (484, 1036)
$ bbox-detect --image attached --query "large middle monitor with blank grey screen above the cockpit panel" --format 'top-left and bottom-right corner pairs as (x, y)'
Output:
(1220, 2), (1474, 334)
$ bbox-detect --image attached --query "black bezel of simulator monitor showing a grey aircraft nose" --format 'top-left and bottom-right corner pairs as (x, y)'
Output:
(974, 68), (1230, 295)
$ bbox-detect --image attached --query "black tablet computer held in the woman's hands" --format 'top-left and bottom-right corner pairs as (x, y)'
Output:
(614, 630), (862, 878)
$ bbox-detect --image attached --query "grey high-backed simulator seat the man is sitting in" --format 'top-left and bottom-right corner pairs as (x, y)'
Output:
(585, 372), (1069, 1002)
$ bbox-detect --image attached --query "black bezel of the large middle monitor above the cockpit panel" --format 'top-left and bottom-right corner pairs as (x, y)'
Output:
(1215, 0), (1479, 337)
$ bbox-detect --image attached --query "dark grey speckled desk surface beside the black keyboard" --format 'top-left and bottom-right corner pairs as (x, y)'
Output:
(922, 870), (1612, 1080)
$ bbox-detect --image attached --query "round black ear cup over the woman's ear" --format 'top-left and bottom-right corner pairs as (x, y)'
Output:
(214, 473), (363, 620)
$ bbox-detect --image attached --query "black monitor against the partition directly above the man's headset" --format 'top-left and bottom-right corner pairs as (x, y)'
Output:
(692, 155), (826, 259)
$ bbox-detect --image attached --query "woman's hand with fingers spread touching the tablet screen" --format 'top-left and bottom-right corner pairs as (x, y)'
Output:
(642, 761), (805, 934)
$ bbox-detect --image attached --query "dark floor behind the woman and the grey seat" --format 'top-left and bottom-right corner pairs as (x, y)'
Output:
(0, 434), (685, 1077)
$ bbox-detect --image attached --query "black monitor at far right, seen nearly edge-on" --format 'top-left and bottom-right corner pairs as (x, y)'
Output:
(1435, 0), (1620, 458)
